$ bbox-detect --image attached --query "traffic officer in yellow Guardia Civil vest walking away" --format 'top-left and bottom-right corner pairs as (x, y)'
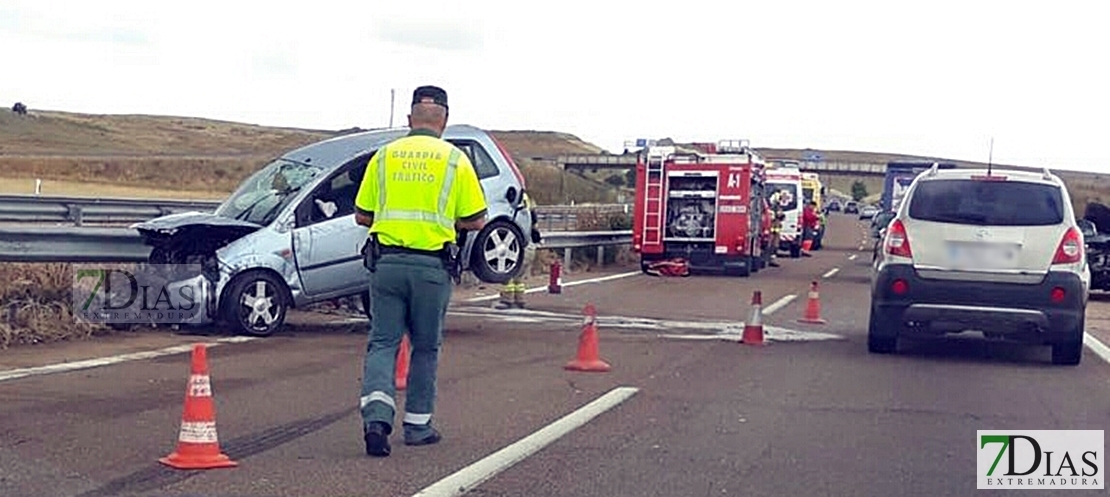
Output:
(355, 87), (486, 457)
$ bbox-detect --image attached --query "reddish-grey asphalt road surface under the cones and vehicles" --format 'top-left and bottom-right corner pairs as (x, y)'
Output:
(0, 215), (1110, 497)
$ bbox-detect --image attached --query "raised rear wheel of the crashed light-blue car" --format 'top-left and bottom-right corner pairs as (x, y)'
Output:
(471, 220), (524, 283)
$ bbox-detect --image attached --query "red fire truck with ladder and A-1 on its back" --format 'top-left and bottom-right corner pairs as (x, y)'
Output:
(633, 140), (765, 276)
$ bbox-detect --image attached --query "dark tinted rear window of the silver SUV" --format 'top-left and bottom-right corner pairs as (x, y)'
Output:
(909, 180), (1063, 226)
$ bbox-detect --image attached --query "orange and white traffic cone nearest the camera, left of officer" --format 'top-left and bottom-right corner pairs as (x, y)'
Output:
(158, 344), (239, 469)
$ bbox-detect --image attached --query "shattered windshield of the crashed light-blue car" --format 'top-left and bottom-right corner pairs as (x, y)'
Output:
(215, 159), (322, 226)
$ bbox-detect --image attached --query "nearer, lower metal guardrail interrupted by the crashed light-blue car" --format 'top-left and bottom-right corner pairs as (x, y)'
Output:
(0, 226), (632, 263)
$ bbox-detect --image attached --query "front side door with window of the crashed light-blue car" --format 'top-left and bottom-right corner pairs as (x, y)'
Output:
(293, 154), (371, 300)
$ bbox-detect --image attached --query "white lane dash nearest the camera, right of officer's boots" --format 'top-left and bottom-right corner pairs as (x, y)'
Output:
(413, 387), (639, 497)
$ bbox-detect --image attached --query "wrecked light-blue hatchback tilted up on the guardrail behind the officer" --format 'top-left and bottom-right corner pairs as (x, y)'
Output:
(133, 125), (541, 336)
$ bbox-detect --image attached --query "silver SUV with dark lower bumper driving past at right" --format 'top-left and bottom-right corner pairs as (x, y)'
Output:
(868, 166), (1090, 365)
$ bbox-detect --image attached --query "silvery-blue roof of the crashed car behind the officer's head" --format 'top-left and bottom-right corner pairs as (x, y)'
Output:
(282, 124), (487, 171)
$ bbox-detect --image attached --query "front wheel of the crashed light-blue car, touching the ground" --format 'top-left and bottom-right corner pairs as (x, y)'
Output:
(221, 271), (289, 336)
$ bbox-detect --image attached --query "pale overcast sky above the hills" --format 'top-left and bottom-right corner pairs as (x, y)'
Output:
(0, 0), (1110, 172)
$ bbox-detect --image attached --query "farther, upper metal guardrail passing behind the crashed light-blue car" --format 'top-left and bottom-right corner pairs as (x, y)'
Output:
(0, 195), (630, 231)
